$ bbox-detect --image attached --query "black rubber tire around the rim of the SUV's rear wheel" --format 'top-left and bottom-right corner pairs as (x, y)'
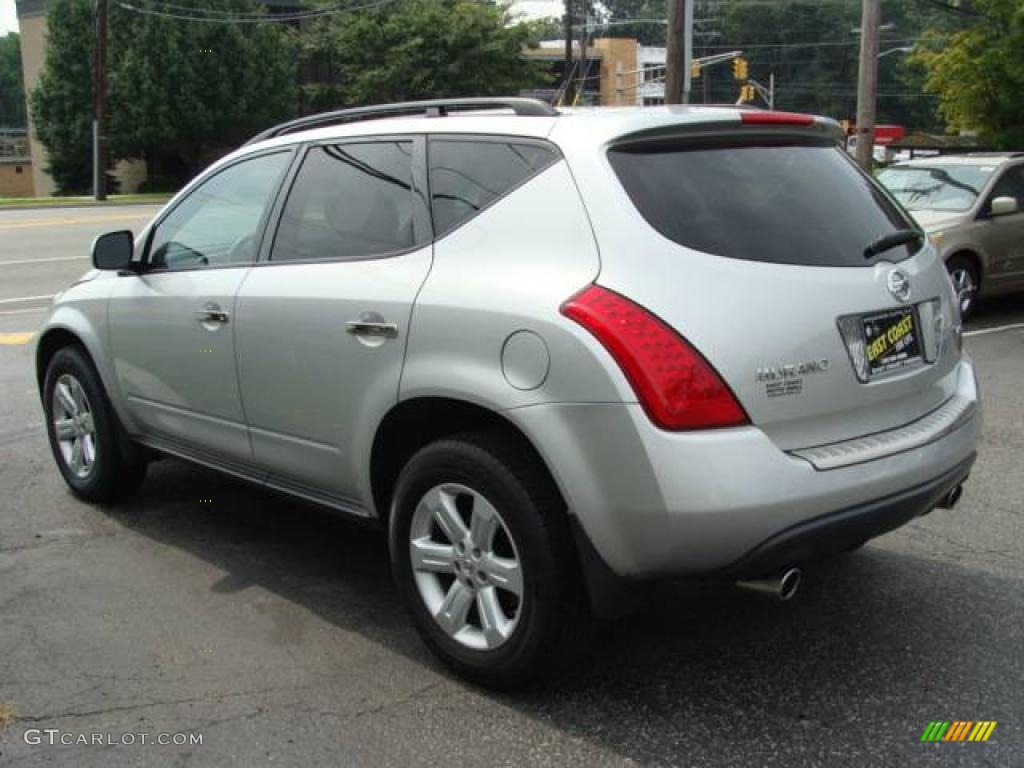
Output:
(389, 433), (587, 689)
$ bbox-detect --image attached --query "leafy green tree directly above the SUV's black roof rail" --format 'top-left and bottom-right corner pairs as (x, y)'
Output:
(302, 0), (547, 110)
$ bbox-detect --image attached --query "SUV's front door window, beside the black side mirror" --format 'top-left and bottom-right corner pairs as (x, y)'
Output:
(150, 152), (291, 269)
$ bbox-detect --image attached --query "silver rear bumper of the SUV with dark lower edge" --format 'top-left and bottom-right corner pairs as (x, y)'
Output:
(506, 358), (981, 579)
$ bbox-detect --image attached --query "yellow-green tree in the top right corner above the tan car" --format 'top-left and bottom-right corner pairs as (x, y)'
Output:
(915, 0), (1024, 148)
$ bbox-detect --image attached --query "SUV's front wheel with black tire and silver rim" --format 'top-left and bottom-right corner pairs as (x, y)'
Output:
(43, 346), (145, 502)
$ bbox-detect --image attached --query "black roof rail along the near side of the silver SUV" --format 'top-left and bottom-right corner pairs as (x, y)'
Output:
(246, 96), (558, 145)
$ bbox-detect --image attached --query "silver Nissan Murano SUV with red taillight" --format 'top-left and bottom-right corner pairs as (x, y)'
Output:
(36, 99), (980, 686)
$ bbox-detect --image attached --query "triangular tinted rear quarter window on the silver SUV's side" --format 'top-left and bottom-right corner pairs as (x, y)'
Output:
(430, 138), (559, 238)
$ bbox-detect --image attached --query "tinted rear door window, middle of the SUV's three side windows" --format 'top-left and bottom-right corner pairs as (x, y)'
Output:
(270, 141), (416, 261)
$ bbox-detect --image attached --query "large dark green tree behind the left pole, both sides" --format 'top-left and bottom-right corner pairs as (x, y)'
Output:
(32, 0), (296, 194)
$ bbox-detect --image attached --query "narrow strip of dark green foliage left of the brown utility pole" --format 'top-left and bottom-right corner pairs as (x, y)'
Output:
(30, 0), (93, 195)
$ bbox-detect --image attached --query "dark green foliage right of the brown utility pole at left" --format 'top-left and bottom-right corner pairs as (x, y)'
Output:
(110, 0), (297, 187)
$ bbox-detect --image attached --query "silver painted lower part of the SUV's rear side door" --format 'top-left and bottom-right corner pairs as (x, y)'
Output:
(236, 245), (431, 512)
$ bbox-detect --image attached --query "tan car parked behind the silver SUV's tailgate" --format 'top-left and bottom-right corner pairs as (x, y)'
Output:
(879, 153), (1024, 317)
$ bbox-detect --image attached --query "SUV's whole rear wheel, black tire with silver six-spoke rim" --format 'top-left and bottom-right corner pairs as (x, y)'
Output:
(390, 434), (584, 688)
